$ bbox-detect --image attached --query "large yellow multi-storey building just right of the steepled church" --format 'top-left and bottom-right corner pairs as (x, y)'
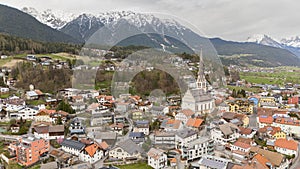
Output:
(226, 98), (254, 114)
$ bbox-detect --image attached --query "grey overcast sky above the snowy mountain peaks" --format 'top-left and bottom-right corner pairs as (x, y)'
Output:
(0, 0), (300, 41)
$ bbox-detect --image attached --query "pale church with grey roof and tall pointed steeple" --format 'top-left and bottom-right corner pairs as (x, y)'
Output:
(181, 51), (215, 114)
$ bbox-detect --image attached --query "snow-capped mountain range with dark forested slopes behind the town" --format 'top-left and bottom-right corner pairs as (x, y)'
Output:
(0, 5), (300, 66)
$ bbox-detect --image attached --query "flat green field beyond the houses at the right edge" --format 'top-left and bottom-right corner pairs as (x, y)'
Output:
(240, 67), (300, 85)
